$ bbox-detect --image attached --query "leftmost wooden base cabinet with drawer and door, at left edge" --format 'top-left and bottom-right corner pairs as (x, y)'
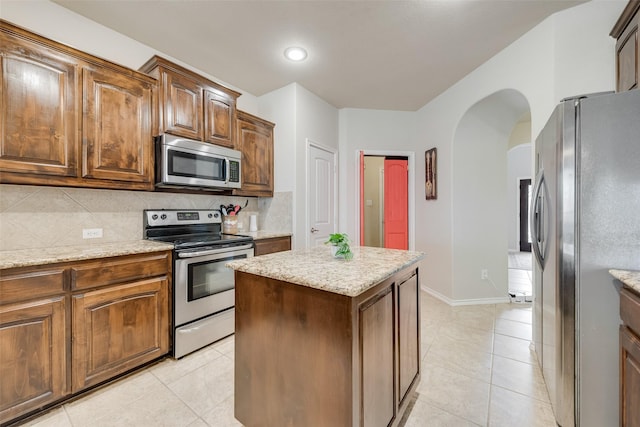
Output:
(0, 267), (69, 423)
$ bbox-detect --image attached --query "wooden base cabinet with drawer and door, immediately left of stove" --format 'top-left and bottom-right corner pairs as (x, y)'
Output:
(71, 252), (170, 393)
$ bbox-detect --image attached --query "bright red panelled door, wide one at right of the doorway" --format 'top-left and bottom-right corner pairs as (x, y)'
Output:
(384, 159), (409, 249)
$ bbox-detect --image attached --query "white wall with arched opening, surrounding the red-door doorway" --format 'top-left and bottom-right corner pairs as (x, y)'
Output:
(340, 0), (626, 303)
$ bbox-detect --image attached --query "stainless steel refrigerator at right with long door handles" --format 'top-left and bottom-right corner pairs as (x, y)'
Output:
(530, 90), (640, 427)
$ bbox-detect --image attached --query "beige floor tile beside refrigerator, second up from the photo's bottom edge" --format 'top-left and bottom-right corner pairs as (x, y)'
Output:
(491, 356), (549, 403)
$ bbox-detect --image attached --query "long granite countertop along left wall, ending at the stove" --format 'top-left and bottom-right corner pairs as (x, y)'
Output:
(0, 240), (173, 269)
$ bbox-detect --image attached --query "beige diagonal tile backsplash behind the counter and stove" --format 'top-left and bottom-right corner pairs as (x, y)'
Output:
(0, 184), (293, 250)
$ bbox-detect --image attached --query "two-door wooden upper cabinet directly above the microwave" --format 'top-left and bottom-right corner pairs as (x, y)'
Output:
(140, 56), (240, 148)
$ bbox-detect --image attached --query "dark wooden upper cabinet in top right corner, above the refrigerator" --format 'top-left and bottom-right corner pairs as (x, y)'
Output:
(610, 0), (640, 92)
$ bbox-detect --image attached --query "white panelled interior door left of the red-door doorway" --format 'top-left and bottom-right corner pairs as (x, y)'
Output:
(307, 141), (337, 247)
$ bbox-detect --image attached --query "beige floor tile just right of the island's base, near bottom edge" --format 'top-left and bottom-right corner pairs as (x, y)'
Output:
(417, 366), (489, 425)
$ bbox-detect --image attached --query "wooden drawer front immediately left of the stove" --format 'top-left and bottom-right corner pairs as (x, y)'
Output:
(71, 252), (171, 290)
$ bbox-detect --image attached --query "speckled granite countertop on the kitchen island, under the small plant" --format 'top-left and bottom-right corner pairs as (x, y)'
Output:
(227, 246), (425, 297)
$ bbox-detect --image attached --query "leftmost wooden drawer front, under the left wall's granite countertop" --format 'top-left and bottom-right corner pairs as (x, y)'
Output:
(0, 267), (65, 304)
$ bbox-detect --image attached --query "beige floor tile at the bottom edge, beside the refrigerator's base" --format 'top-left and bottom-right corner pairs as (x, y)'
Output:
(488, 386), (556, 427)
